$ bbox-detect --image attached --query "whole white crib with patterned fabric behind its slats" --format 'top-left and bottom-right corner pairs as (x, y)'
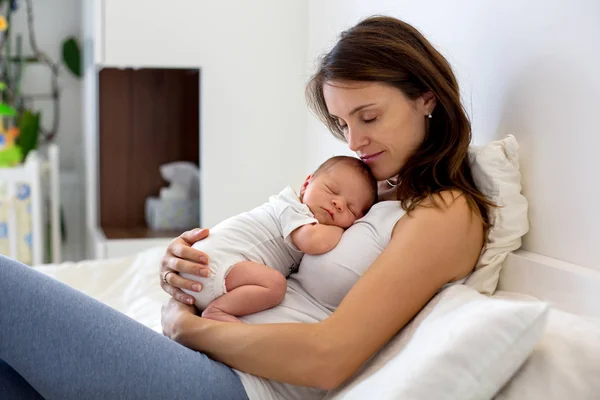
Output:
(0, 145), (61, 265)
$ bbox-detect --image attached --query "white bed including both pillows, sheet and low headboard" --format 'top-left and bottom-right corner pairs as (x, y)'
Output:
(34, 135), (600, 400)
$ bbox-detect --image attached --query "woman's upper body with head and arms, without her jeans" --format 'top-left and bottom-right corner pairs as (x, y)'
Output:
(161, 14), (489, 398)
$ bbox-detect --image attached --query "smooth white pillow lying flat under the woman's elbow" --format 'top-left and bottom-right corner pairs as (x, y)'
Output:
(326, 285), (548, 400)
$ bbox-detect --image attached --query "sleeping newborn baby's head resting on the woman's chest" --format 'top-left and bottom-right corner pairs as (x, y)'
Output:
(300, 156), (377, 229)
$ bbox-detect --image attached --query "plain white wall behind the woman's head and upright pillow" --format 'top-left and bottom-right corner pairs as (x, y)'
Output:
(307, 0), (600, 269)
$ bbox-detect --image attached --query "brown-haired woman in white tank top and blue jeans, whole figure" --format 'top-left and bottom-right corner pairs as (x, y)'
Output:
(0, 17), (491, 399)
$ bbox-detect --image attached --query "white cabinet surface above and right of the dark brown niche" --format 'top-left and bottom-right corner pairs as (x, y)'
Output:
(100, 0), (308, 226)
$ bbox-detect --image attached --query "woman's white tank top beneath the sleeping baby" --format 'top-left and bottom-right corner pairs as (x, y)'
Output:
(236, 201), (405, 400)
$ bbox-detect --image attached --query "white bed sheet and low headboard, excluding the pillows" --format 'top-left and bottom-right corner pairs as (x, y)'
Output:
(35, 247), (600, 400)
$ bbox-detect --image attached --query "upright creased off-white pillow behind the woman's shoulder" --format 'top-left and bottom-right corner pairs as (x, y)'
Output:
(466, 135), (529, 294)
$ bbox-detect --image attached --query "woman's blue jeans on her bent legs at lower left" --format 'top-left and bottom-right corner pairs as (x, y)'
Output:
(0, 256), (248, 400)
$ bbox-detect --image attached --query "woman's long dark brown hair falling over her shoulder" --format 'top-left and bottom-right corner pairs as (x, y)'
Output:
(306, 16), (495, 228)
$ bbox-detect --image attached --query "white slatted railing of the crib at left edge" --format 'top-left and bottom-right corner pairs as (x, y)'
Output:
(0, 145), (61, 265)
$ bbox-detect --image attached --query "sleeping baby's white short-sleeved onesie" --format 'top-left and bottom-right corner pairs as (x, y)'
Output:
(181, 186), (317, 310)
